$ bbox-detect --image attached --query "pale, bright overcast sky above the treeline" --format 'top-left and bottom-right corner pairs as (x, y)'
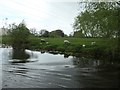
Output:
(0, 0), (80, 35)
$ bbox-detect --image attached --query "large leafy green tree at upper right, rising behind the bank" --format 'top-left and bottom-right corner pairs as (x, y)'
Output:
(73, 2), (119, 38)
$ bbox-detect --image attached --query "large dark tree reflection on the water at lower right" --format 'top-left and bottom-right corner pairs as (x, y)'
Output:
(72, 57), (120, 87)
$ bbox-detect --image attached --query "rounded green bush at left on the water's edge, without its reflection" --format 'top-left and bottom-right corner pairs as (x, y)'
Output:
(9, 22), (30, 50)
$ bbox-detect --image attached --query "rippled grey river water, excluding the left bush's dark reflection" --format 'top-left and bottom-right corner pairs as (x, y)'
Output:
(0, 48), (119, 88)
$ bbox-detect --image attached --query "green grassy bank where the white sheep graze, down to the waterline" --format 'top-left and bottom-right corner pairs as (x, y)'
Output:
(2, 37), (120, 60)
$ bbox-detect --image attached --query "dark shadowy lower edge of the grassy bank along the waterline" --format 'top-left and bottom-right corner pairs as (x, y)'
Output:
(30, 45), (120, 61)
